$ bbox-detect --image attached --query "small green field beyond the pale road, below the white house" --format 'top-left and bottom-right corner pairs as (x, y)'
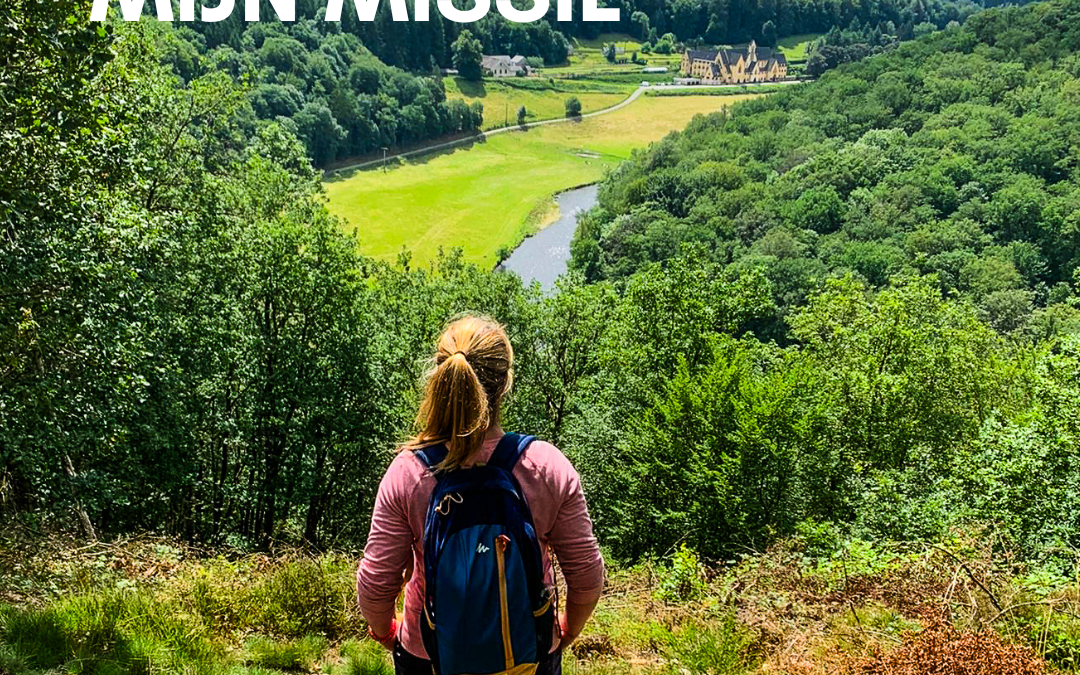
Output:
(443, 78), (635, 131)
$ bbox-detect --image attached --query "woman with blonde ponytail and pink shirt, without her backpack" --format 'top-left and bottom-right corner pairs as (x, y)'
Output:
(356, 316), (604, 675)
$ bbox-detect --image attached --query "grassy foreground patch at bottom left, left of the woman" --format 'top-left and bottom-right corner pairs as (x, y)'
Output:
(0, 555), (362, 675)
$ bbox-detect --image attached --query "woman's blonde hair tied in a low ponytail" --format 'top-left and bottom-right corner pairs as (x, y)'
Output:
(403, 315), (514, 471)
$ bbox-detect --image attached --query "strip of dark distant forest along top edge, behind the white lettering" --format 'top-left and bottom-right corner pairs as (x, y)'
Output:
(183, 0), (996, 65)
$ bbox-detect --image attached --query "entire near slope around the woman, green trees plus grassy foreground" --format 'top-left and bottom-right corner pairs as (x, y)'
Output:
(6, 0), (1080, 675)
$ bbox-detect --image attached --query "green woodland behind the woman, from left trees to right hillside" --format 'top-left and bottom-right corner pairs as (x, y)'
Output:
(6, 0), (1080, 578)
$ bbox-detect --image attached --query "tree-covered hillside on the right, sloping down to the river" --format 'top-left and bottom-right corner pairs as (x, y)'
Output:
(573, 2), (1080, 339)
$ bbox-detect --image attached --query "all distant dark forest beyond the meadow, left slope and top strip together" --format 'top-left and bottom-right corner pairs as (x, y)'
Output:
(147, 0), (1023, 166)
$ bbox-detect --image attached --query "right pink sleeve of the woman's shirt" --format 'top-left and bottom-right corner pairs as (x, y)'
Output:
(548, 453), (604, 605)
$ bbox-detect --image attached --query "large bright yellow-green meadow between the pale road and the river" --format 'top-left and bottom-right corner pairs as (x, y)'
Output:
(325, 95), (753, 266)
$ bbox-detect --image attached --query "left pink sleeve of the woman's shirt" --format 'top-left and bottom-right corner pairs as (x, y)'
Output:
(356, 455), (413, 623)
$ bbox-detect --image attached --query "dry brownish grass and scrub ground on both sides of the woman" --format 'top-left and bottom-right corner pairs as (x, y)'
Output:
(0, 535), (1080, 675)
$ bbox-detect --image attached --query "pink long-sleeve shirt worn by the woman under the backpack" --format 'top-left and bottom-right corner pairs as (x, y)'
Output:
(356, 438), (604, 659)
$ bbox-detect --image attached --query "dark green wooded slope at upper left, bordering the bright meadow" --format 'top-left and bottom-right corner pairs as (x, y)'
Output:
(157, 19), (484, 166)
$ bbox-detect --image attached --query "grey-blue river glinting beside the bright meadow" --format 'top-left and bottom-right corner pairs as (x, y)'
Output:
(499, 185), (597, 293)
